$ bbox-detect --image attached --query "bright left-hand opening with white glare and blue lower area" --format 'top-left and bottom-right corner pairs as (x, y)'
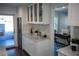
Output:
(0, 15), (14, 48)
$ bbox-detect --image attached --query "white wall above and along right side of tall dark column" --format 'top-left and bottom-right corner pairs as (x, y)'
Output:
(17, 6), (30, 49)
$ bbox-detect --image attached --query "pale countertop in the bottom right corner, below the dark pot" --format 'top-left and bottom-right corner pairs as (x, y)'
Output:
(57, 46), (79, 56)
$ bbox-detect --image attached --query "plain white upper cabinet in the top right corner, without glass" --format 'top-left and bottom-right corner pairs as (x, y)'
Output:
(68, 3), (79, 26)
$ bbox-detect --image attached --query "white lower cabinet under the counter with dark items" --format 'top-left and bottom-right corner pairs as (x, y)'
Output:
(23, 38), (50, 56)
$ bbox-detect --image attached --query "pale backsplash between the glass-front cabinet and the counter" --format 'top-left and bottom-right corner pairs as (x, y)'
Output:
(28, 24), (50, 38)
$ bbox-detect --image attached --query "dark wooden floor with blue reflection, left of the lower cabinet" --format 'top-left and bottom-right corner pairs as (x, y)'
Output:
(6, 48), (30, 56)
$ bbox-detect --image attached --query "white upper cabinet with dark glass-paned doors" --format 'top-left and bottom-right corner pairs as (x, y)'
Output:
(28, 3), (50, 24)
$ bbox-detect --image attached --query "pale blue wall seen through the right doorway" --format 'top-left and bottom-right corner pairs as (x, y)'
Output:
(58, 13), (68, 33)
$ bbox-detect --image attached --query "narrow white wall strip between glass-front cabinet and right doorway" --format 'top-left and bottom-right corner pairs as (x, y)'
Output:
(50, 4), (55, 56)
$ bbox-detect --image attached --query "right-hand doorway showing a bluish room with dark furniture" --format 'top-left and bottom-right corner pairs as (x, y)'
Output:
(54, 5), (70, 56)
